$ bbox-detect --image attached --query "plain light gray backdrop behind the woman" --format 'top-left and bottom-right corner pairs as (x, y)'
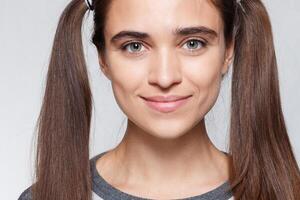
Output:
(0, 0), (300, 200)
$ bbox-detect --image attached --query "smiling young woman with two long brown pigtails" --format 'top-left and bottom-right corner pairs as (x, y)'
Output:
(19, 0), (300, 200)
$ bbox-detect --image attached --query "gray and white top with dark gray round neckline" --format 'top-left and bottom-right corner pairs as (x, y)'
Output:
(18, 151), (233, 200)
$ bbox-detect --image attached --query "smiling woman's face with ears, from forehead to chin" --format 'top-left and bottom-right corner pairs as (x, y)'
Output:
(100, 0), (232, 138)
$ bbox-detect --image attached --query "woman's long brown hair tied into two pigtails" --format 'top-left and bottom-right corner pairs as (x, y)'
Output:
(32, 0), (300, 200)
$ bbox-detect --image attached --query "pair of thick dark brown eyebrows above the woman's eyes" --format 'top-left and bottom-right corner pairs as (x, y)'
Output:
(111, 26), (218, 43)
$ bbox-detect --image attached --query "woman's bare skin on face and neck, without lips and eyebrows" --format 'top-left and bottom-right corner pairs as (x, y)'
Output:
(96, 0), (233, 199)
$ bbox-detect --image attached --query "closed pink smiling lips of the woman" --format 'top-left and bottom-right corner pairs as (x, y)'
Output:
(142, 95), (191, 113)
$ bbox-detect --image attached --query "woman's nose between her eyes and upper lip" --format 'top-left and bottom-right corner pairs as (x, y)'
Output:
(148, 48), (182, 88)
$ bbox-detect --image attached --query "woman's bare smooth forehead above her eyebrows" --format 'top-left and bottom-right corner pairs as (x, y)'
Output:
(105, 0), (223, 34)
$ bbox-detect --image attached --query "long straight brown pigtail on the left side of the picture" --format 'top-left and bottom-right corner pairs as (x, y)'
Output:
(32, 0), (91, 200)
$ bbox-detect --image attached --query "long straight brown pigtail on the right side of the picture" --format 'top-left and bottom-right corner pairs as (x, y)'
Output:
(229, 0), (300, 200)
